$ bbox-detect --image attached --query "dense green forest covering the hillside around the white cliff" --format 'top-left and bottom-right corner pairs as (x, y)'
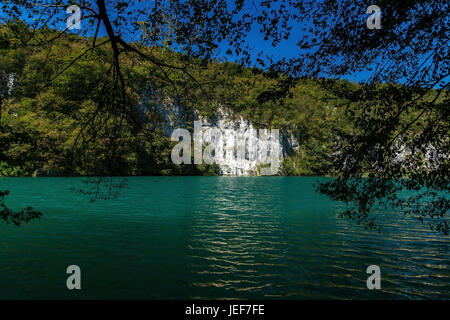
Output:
(0, 22), (432, 176)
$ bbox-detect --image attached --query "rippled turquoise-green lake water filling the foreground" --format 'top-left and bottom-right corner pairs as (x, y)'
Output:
(0, 177), (450, 299)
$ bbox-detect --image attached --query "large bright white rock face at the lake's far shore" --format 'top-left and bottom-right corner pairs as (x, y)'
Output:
(141, 95), (299, 176)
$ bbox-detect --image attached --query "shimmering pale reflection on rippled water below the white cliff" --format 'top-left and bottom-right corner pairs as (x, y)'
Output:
(189, 177), (287, 298)
